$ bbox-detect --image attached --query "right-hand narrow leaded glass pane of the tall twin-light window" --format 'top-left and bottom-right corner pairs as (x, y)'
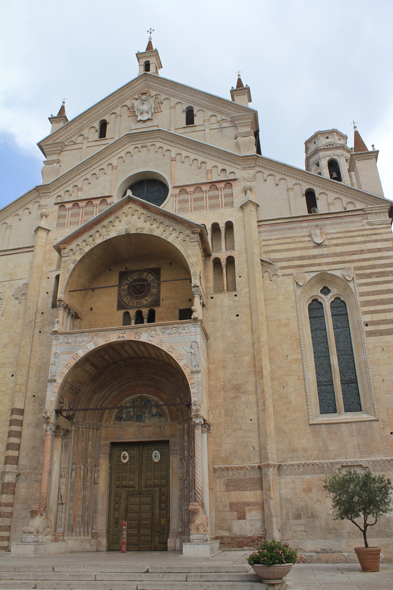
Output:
(330, 297), (362, 412)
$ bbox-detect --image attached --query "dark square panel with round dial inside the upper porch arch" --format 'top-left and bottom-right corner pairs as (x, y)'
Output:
(117, 268), (161, 309)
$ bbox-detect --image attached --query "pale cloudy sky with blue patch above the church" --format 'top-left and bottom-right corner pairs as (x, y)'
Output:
(0, 0), (393, 213)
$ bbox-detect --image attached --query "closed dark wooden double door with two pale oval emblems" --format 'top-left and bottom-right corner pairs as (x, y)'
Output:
(108, 441), (169, 551)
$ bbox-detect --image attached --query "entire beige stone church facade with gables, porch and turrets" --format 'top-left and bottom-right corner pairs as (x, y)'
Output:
(0, 40), (393, 555)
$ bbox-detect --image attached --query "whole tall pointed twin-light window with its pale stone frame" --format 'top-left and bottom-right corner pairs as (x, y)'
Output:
(296, 271), (376, 424)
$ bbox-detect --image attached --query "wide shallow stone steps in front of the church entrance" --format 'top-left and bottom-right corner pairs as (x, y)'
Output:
(0, 556), (267, 590)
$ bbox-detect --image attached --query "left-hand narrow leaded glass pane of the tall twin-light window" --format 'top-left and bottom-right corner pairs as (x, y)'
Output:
(308, 299), (337, 414)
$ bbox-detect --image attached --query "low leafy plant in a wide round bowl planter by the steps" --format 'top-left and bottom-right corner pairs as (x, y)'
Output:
(247, 539), (297, 583)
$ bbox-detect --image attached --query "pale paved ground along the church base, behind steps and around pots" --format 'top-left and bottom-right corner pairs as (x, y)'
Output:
(0, 551), (393, 590)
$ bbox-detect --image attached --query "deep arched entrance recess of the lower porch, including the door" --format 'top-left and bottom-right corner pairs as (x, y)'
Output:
(50, 339), (194, 551)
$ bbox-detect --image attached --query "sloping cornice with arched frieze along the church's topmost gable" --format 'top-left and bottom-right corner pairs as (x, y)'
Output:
(38, 72), (258, 156)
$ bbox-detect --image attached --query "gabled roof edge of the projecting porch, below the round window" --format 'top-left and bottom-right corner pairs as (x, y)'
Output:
(53, 194), (211, 255)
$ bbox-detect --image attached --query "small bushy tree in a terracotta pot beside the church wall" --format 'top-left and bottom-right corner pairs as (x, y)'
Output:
(323, 469), (392, 572)
